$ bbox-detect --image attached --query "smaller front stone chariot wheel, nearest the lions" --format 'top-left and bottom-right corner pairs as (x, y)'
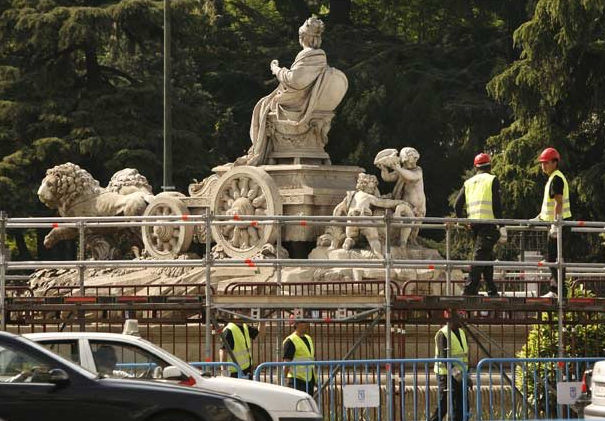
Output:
(143, 193), (194, 259)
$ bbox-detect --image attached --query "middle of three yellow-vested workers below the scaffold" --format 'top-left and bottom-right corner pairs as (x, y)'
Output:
(283, 320), (316, 395)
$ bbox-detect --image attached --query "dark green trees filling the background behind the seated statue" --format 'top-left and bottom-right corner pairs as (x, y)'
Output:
(0, 0), (536, 256)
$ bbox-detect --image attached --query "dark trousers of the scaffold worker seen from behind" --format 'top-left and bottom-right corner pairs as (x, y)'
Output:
(463, 224), (500, 297)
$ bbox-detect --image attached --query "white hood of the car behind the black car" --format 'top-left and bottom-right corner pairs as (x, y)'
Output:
(199, 377), (309, 411)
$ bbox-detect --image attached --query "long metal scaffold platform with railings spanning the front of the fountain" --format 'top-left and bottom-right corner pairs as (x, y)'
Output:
(0, 213), (605, 361)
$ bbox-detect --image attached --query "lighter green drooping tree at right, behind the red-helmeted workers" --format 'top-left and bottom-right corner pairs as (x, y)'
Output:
(488, 0), (605, 220)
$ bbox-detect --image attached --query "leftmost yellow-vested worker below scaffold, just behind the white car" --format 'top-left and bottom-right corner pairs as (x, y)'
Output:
(219, 322), (264, 379)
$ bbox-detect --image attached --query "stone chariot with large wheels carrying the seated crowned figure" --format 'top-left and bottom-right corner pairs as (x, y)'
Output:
(143, 18), (363, 259)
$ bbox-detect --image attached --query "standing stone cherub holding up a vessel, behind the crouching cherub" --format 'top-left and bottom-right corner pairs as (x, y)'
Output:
(374, 147), (426, 245)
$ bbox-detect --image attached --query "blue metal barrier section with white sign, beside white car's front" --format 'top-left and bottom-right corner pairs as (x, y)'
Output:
(254, 358), (468, 421)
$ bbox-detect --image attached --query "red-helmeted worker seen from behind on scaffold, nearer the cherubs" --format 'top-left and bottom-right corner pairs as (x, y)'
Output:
(454, 153), (507, 297)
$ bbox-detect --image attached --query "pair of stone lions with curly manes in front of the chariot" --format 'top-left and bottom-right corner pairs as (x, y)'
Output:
(38, 162), (153, 248)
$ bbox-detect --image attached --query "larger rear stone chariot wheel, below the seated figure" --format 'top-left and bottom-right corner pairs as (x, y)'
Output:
(210, 166), (283, 259)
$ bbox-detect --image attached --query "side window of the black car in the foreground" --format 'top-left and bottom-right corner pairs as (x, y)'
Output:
(0, 345), (50, 383)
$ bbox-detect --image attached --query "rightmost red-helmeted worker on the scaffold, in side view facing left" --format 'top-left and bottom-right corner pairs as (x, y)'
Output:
(536, 148), (571, 298)
